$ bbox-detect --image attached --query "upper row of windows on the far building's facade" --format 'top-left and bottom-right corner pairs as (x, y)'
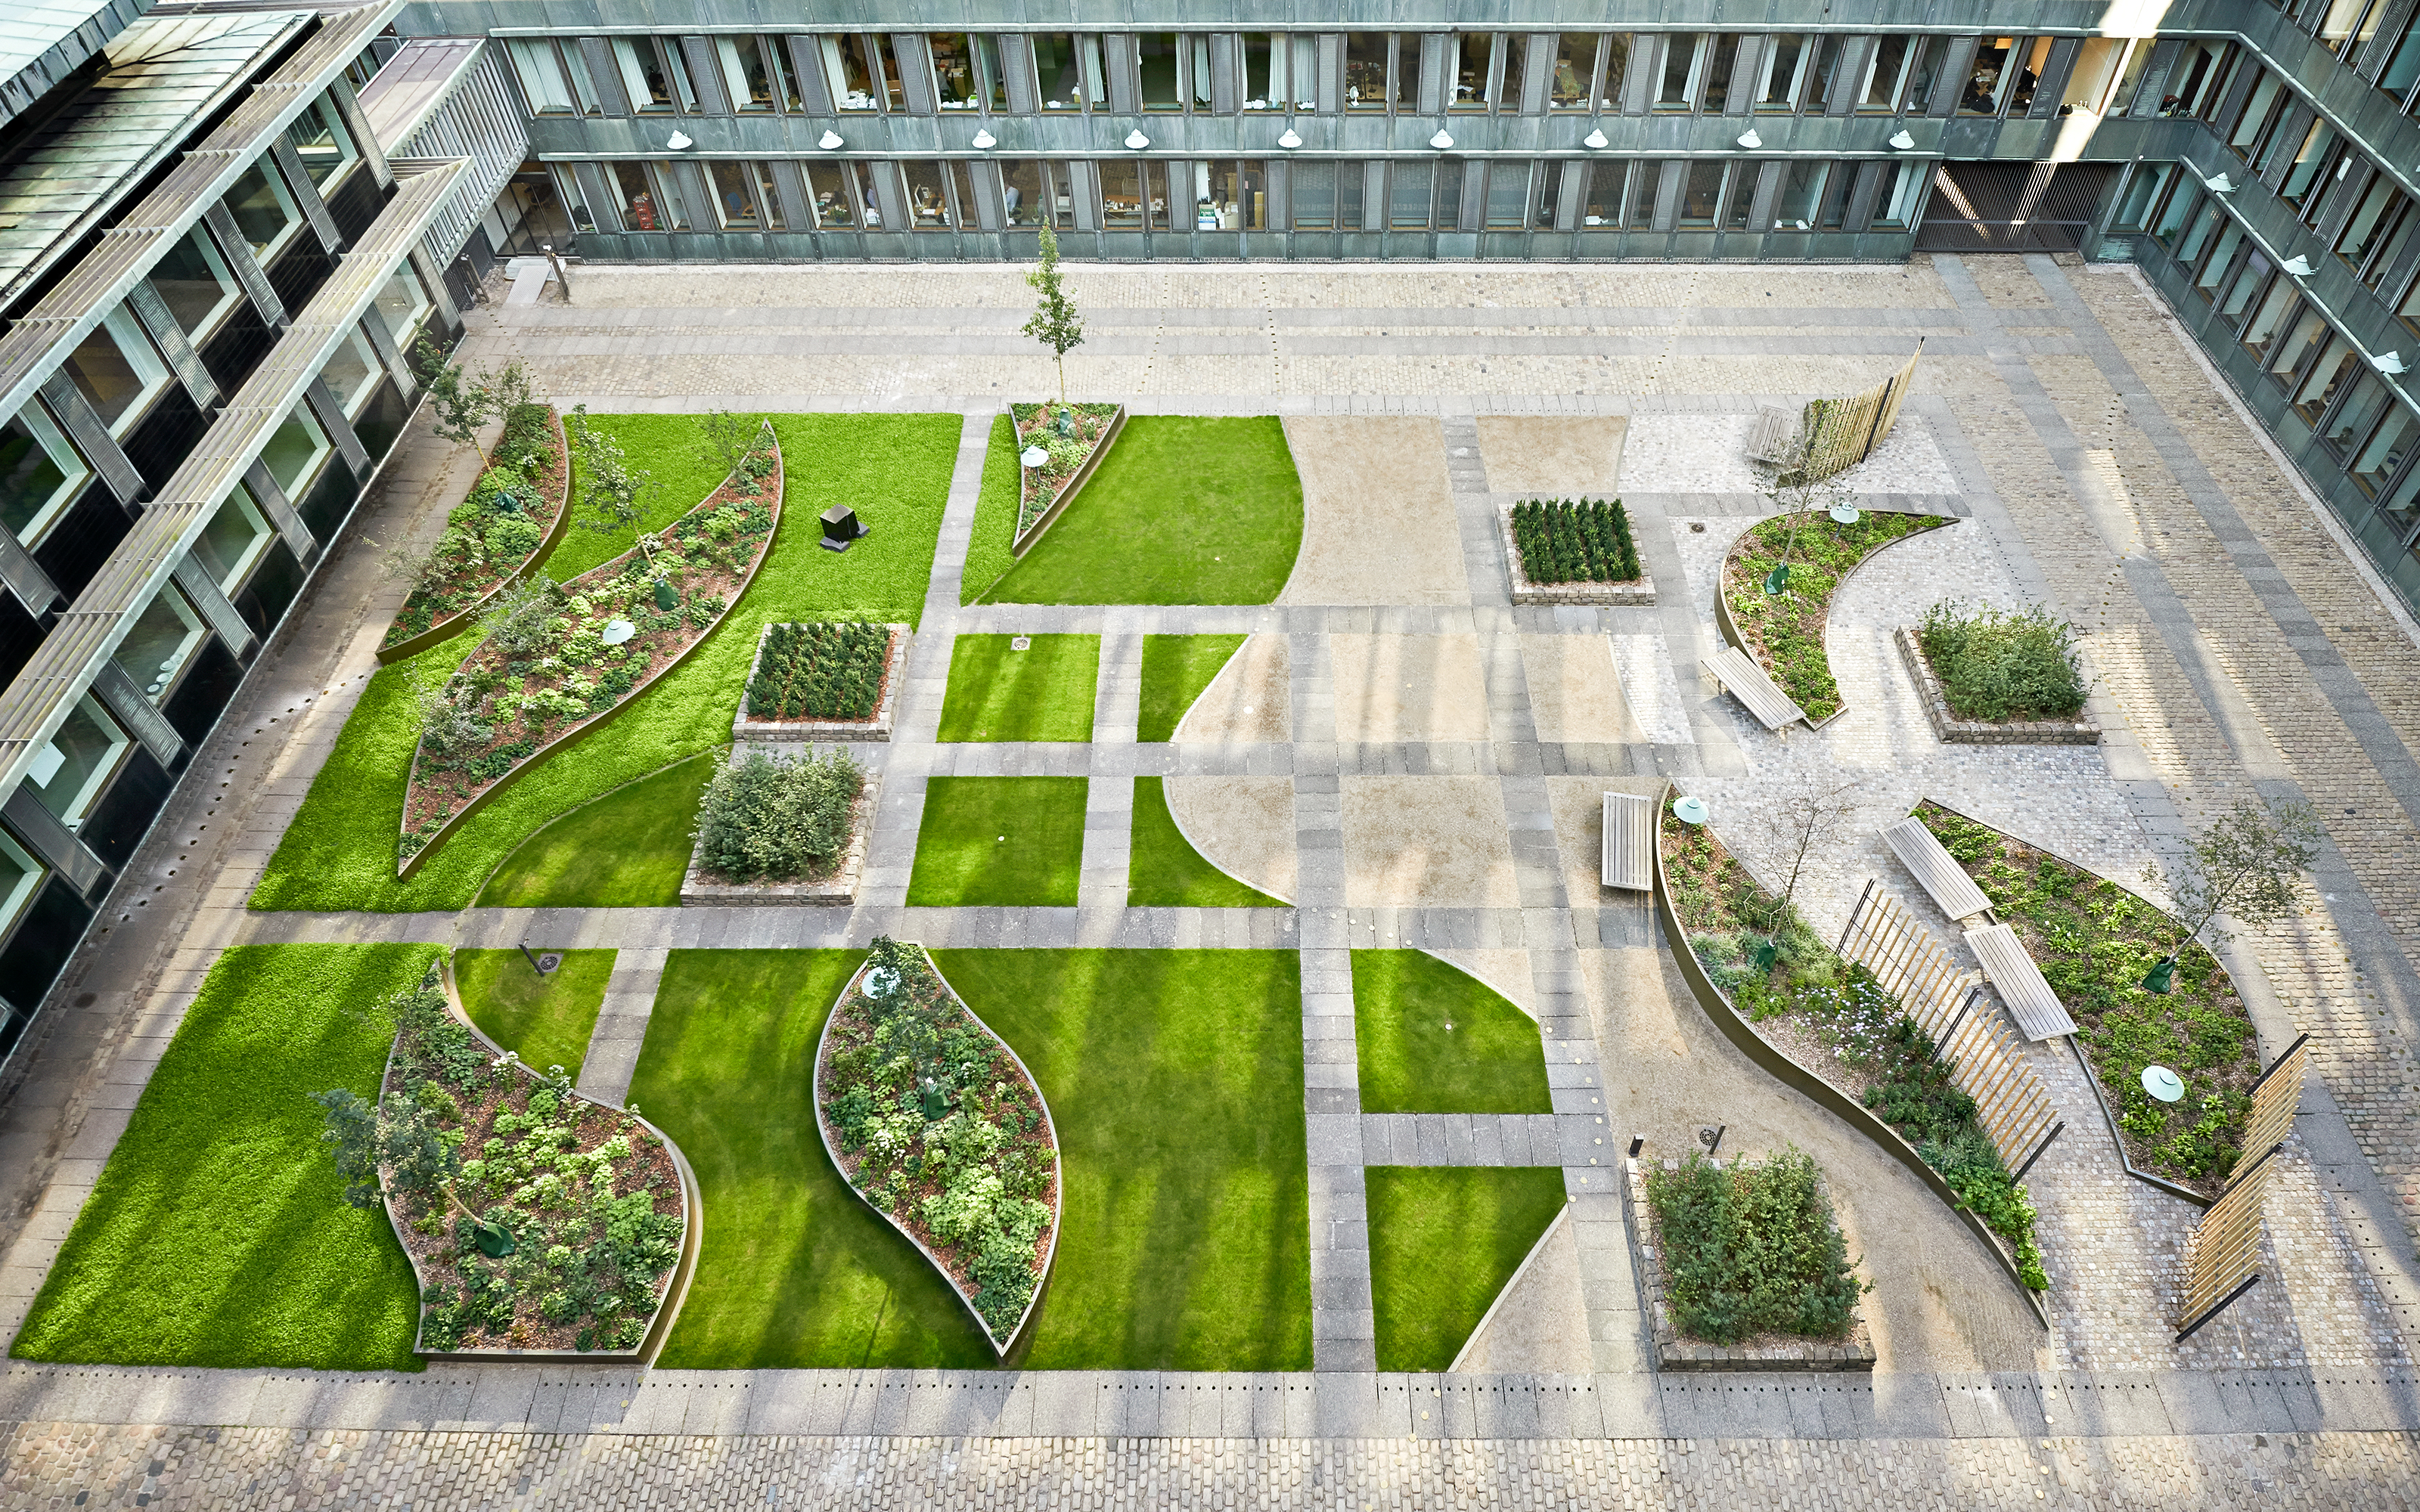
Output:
(506, 32), (2152, 116)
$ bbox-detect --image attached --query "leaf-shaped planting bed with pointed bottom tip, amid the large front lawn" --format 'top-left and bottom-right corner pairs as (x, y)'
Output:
(815, 936), (1060, 1355)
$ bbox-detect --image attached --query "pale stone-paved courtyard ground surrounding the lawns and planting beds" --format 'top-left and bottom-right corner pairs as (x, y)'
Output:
(0, 256), (2420, 1510)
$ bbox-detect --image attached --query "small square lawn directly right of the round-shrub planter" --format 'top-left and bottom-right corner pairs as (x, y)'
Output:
(908, 776), (1084, 907)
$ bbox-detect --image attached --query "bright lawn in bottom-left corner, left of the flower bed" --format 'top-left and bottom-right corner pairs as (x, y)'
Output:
(10, 946), (436, 1369)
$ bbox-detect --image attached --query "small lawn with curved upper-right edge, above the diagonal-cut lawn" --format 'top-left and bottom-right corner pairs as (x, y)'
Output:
(1353, 951), (1553, 1113)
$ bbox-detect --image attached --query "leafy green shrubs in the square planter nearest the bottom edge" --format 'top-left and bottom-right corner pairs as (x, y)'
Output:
(1648, 1149), (1866, 1345)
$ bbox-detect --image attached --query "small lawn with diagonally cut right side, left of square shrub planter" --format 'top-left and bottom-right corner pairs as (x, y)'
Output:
(1367, 1166), (1563, 1369)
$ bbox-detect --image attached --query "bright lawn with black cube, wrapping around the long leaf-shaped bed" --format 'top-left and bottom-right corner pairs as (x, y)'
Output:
(252, 414), (960, 912)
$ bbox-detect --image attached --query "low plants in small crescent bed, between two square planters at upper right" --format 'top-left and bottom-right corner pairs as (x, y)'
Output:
(1723, 510), (1950, 723)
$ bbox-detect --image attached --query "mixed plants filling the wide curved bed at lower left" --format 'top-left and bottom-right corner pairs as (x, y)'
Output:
(315, 963), (687, 1352)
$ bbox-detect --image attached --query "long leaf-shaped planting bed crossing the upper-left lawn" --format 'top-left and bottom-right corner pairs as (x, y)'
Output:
(395, 426), (782, 875)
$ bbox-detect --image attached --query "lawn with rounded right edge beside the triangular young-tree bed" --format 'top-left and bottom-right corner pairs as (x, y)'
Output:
(985, 416), (1302, 605)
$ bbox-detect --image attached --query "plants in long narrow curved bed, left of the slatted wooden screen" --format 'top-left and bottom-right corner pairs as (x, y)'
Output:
(1660, 808), (2049, 1292)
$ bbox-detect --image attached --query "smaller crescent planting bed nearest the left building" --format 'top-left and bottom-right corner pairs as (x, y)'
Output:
(377, 404), (571, 665)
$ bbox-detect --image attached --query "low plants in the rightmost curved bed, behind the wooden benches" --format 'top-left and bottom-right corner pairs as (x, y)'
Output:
(1916, 803), (2260, 1195)
